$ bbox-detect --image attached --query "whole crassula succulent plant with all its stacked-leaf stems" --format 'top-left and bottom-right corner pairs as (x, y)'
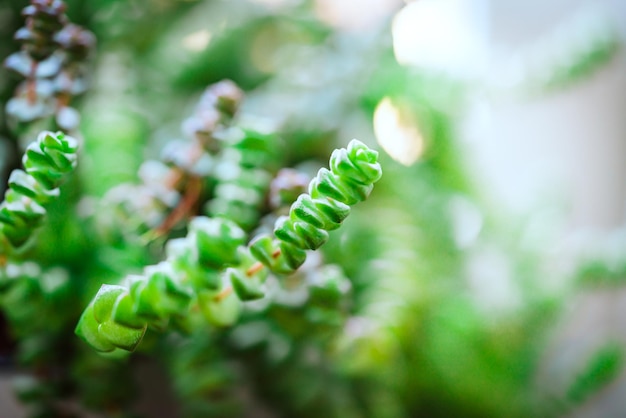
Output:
(0, 0), (381, 416)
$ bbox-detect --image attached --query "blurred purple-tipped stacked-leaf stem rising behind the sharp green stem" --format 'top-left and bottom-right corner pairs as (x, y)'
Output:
(99, 80), (247, 240)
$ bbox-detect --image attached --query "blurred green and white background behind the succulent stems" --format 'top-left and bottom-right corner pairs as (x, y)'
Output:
(0, 0), (626, 417)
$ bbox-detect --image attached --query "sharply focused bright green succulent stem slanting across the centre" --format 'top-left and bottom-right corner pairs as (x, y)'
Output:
(76, 140), (382, 352)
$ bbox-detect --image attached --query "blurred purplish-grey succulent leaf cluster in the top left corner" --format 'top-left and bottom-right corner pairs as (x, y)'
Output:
(4, 0), (95, 131)
